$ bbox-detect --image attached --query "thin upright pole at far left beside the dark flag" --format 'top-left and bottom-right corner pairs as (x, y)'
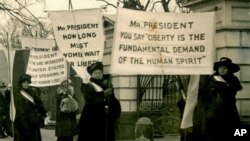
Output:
(7, 32), (15, 137)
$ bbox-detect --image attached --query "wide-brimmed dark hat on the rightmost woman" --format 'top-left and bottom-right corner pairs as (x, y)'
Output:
(214, 57), (240, 73)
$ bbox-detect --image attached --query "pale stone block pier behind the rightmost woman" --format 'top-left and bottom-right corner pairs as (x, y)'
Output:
(184, 0), (250, 120)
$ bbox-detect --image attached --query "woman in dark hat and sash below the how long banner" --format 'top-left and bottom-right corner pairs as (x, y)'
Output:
(78, 62), (121, 141)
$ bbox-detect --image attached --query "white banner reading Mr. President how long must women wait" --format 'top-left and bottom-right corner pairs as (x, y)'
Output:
(50, 9), (104, 82)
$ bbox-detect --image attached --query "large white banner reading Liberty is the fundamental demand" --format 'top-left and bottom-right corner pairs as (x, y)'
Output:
(111, 8), (215, 74)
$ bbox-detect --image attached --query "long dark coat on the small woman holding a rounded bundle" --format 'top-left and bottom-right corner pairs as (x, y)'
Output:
(56, 85), (77, 137)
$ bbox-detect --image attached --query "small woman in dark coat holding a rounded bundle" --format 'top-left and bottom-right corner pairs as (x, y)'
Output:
(56, 79), (77, 141)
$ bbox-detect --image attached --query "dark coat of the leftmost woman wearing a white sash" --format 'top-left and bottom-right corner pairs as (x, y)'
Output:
(14, 89), (46, 141)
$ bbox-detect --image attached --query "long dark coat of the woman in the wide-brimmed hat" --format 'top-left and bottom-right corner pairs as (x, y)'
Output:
(194, 74), (242, 141)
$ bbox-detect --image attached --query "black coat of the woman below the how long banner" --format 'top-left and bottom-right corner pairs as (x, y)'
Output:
(78, 79), (121, 141)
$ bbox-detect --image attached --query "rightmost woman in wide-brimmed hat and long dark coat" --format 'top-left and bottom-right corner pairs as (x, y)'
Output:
(197, 57), (242, 141)
